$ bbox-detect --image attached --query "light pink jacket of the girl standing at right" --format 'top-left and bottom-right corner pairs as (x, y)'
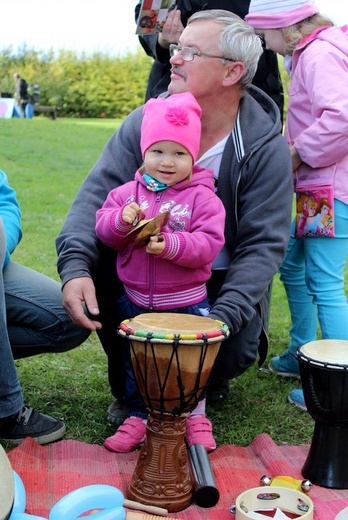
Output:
(285, 26), (348, 204)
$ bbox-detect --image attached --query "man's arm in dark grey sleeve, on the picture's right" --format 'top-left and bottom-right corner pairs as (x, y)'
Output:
(210, 134), (293, 335)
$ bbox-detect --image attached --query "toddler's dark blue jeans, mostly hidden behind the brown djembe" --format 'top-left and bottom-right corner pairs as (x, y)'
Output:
(118, 295), (210, 419)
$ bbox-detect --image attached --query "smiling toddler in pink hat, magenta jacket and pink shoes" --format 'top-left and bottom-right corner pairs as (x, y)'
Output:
(96, 92), (225, 452)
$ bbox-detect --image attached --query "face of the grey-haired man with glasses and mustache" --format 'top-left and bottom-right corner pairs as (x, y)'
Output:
(168, 20), (229, 101)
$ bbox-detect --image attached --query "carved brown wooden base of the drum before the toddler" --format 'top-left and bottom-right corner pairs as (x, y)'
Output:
(128, 412), (193, 513)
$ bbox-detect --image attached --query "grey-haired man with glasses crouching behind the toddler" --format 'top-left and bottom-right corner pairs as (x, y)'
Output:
(57, 10), (293, 444)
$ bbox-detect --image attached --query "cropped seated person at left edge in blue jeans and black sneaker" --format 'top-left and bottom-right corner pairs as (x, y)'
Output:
(0, 170), (89, 444)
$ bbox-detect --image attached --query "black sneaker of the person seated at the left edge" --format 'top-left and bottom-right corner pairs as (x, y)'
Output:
(0, 406), (65, 444)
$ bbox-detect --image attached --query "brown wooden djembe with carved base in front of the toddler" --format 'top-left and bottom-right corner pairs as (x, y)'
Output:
(118, 313), (229, 512)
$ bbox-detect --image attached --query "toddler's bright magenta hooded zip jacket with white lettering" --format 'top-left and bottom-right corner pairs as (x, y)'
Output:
(96, 166), (225, 310)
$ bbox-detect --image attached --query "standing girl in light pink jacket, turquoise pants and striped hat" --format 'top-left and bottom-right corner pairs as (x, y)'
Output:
(246, 0), (348, 409)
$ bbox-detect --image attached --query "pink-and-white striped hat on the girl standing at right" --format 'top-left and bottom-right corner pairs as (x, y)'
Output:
(245, 0), (319, 29)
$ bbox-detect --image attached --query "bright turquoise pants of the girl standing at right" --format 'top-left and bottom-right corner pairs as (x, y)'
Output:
(280, 200), (348, 354)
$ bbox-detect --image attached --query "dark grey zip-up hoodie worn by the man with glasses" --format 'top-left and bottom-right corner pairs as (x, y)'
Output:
(56, 87), (293, 376)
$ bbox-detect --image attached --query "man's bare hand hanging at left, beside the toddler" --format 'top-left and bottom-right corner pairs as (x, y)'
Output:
(63, 277), (102, 330)
